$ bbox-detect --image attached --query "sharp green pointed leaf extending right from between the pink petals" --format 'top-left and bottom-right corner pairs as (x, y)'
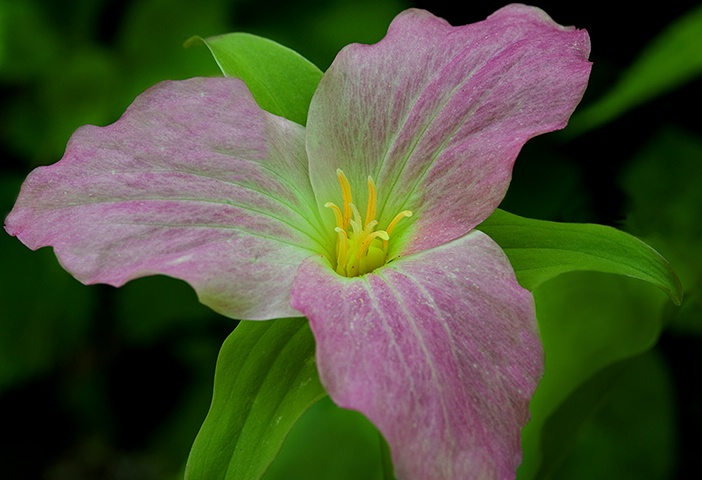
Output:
(477, 210), (682, 305)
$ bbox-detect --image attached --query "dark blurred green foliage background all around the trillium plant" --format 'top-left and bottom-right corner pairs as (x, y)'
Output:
(0, 0), (702, 480)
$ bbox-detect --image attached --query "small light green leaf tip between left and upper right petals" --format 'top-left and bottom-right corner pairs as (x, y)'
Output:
(186, 33), (322, 125)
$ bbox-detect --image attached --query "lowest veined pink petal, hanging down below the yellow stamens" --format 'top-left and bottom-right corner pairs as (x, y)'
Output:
(292, 231), (542, 480)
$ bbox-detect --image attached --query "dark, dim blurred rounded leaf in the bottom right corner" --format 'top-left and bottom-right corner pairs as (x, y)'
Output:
(552, 350), (679, 480)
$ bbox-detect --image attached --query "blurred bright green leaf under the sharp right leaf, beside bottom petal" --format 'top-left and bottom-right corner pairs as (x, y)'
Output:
(518, 272), (667, 480)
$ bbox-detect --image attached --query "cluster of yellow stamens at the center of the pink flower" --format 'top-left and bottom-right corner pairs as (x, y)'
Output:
(324, 169), (412, 277)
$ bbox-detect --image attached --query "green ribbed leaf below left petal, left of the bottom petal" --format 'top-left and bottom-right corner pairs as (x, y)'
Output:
(185, 318), (326, 480)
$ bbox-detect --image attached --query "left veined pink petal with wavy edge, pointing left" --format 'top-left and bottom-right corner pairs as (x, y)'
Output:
(5, 78), (327, 319)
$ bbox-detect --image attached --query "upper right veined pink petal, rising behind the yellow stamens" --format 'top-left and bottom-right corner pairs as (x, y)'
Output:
(307, 5), (590, 256)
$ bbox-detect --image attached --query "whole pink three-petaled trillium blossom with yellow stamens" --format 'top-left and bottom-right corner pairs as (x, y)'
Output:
(6, 5), (590, 480)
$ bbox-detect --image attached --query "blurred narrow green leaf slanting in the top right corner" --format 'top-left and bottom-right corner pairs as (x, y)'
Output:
(566, 5), (702, 136)
